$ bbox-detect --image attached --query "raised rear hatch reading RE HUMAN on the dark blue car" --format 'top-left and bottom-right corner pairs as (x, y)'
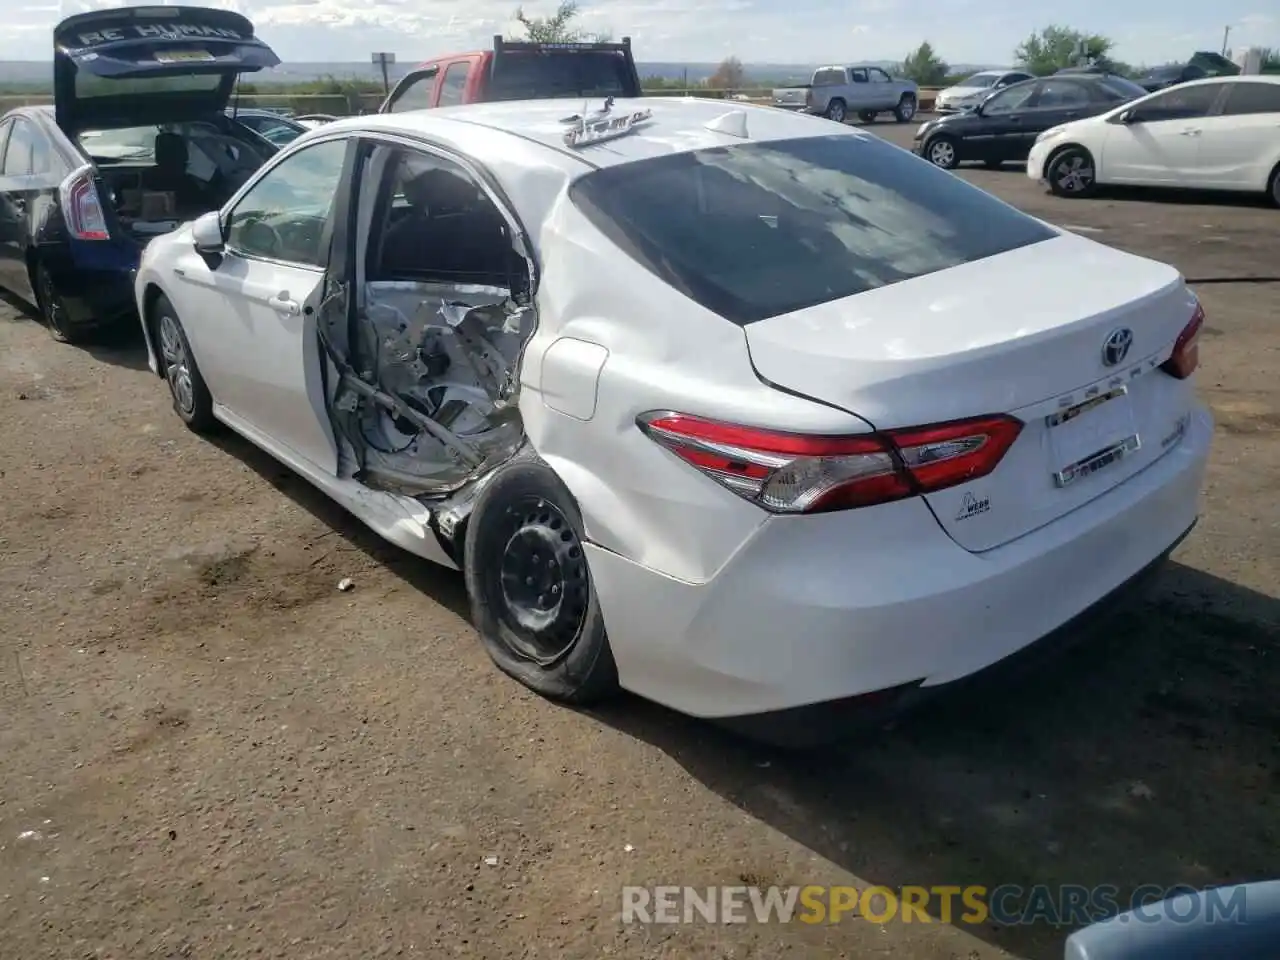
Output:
(54, 6), (280, 138)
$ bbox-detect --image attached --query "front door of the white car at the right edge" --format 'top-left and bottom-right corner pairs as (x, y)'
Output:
(1096, 83), (1226, 187)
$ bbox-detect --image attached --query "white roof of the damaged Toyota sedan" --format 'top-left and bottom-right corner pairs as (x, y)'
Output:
(316, 97), (867, 166)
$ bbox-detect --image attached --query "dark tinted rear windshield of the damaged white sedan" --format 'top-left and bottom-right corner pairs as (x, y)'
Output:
(570, 136), (1055, 324)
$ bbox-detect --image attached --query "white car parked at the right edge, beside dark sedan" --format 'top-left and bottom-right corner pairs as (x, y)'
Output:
(1027, 74), (1280, 206)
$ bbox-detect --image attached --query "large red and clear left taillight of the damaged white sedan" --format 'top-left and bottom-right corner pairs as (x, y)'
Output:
(636, 412), (1023, 513)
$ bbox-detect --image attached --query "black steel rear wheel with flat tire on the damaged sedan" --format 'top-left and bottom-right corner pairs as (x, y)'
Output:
(462, 460), (618, 704)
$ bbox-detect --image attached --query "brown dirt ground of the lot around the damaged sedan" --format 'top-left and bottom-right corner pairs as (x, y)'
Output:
(0, 124), (1280, 960)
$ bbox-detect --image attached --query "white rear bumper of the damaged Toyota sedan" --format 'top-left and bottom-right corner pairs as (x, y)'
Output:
(588, 407), (1212, 726)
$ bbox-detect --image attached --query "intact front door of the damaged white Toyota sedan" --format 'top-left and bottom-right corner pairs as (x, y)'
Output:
(175, 137), (355, 472)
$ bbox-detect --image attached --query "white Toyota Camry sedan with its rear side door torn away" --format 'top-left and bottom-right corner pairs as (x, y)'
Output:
(137, 99), (1212, 742)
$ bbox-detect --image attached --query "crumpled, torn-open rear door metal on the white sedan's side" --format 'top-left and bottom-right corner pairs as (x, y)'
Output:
(323, 280), (536, 497)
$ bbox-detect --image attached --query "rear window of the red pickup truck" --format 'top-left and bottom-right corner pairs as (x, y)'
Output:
(486, 50), (639, 100)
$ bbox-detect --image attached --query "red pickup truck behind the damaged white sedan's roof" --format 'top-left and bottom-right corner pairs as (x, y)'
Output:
(378, 36), (641, 114)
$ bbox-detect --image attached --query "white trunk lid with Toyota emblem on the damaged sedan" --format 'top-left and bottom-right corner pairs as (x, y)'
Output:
(745, 234), (1197, 552)
